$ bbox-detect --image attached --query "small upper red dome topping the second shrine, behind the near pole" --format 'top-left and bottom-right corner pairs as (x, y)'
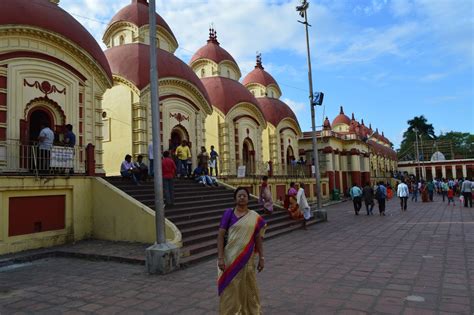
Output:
(109, 0), (178, 42)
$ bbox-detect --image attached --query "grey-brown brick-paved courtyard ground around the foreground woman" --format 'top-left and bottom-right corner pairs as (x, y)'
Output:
(0, 198), (474, 315)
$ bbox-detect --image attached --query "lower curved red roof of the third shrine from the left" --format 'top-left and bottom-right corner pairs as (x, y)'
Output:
(201, 77), (263, 115)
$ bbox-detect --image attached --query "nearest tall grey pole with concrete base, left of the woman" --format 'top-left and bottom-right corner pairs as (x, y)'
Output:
(146, 0), (179, 274)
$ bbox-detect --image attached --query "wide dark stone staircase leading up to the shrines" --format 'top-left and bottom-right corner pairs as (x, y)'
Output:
(106, 177), (320, 266)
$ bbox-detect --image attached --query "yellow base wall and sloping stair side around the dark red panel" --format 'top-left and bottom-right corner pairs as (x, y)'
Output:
(0, 176), (181, 255)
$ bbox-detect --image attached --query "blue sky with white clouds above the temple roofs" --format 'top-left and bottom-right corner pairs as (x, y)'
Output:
(60, 0), (474, 148)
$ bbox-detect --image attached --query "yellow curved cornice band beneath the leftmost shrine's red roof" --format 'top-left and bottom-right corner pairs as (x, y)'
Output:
(0, 25), (112, 92)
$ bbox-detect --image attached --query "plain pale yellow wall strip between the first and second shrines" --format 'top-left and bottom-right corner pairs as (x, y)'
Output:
(102, 84), (133, 175)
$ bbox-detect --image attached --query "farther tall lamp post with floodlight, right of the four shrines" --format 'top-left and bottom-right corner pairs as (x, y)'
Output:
(296, 0), (321, 210)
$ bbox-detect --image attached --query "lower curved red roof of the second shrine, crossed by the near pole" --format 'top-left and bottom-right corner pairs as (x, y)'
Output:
(105, 44), (211, 104)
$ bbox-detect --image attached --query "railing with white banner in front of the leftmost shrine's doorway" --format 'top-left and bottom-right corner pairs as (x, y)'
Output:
(0, 139), (86, 175)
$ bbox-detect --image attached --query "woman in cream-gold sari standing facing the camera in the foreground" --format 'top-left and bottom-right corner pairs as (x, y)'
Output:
(217, 187), (266, 315)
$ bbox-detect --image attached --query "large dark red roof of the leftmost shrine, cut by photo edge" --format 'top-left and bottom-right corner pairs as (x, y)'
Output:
(0, 0), (112, 80)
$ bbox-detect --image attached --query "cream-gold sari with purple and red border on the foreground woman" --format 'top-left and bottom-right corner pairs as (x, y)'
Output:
(218, 210), (265, 315)
